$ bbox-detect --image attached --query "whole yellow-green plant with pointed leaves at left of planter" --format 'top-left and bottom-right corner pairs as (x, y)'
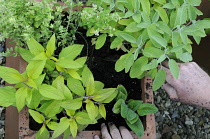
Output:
(0, 35), (118, 139)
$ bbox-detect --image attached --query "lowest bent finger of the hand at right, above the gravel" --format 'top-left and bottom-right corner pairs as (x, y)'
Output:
(163, 83), (179, 100)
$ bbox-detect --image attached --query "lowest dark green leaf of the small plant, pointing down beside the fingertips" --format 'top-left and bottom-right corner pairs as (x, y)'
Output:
(125, 119), (144, 138)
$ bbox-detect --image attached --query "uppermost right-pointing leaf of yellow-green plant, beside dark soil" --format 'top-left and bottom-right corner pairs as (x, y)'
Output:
(59, 44), (84, 60)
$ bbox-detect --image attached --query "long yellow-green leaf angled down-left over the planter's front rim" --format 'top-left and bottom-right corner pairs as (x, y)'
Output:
(52, 117), (70, 139)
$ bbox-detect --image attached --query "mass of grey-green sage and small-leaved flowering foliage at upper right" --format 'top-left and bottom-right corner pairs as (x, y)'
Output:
(80, 0), (210, 90)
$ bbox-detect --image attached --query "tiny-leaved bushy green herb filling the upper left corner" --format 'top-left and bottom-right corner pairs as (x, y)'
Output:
(0, 0), (79, 47)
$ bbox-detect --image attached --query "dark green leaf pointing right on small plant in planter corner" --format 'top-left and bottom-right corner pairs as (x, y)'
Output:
(137, 103), (158, 116)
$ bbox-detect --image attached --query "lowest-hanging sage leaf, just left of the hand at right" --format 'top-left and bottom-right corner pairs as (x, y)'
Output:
(152, 69), (166, 91)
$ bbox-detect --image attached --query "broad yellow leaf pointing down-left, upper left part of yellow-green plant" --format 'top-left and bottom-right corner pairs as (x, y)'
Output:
(26, 59), (46, 79)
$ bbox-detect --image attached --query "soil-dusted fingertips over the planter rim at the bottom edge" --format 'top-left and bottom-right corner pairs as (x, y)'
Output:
(93, 123), (133, 139)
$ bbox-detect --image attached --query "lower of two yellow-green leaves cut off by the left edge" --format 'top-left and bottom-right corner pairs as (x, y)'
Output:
(0, 86), (16, 107)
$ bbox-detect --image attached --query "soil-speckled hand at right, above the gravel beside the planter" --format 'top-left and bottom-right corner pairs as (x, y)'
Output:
(162, 62), (210, 108)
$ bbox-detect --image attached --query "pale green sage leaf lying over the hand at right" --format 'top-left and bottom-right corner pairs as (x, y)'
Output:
(169, 59), (179, 80)
